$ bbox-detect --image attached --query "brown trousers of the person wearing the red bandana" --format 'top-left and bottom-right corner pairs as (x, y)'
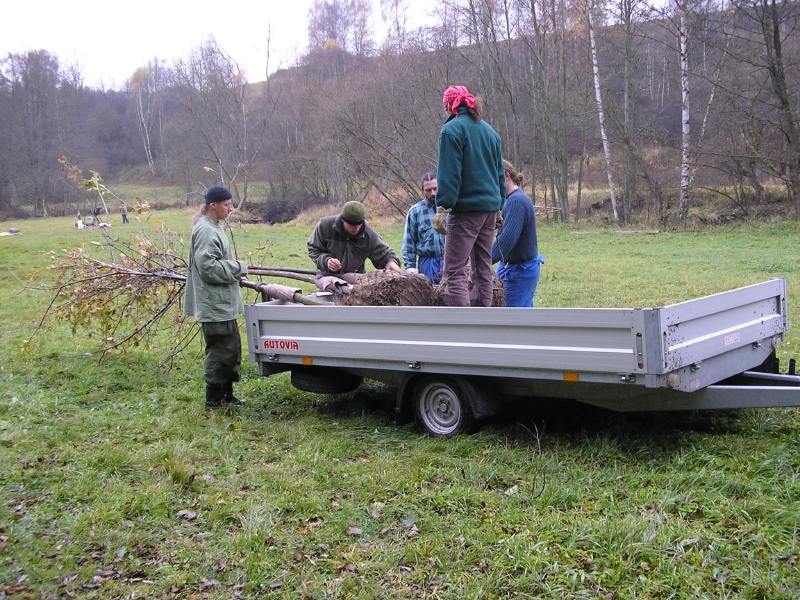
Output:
(443, 211), (497, 306)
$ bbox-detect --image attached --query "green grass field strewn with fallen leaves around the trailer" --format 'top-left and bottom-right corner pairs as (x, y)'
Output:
(0, 210), (800, 599)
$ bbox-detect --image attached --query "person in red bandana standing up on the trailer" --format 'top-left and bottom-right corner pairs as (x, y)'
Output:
(436, 85), (506, 306)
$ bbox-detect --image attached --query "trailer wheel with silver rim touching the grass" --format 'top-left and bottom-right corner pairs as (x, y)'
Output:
(413, 375), (475, 438)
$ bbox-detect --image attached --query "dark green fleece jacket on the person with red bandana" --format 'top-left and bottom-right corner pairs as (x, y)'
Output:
(436, 106), (506, 213)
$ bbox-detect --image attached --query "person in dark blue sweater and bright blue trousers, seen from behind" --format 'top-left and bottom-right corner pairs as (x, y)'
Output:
(492, 160), (544, 307)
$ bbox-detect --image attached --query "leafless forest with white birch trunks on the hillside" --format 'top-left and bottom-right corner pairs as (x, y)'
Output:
(0, 0), (800, 225)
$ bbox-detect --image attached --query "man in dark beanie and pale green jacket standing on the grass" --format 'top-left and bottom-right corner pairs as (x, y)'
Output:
(183, 185), (247, 409)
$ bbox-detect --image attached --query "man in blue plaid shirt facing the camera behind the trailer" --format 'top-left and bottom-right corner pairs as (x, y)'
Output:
(403, 173), (444, 285)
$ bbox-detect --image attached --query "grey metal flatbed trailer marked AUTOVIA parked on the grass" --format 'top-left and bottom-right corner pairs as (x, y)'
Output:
(245, 278), (800, 437)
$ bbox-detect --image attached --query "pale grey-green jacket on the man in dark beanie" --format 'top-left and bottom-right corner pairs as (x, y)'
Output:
(183, 216), (247, 323)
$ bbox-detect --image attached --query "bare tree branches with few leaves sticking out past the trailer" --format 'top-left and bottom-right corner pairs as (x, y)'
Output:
(28, 230), (316, 366)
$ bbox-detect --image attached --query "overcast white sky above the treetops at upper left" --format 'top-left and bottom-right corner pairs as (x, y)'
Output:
(0, 0), (429, 89)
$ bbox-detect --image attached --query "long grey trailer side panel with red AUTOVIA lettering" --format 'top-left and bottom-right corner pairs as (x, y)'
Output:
(246, 303), (646, 373)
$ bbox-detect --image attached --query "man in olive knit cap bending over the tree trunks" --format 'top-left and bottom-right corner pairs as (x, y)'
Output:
(307, 201), (400, 288)
